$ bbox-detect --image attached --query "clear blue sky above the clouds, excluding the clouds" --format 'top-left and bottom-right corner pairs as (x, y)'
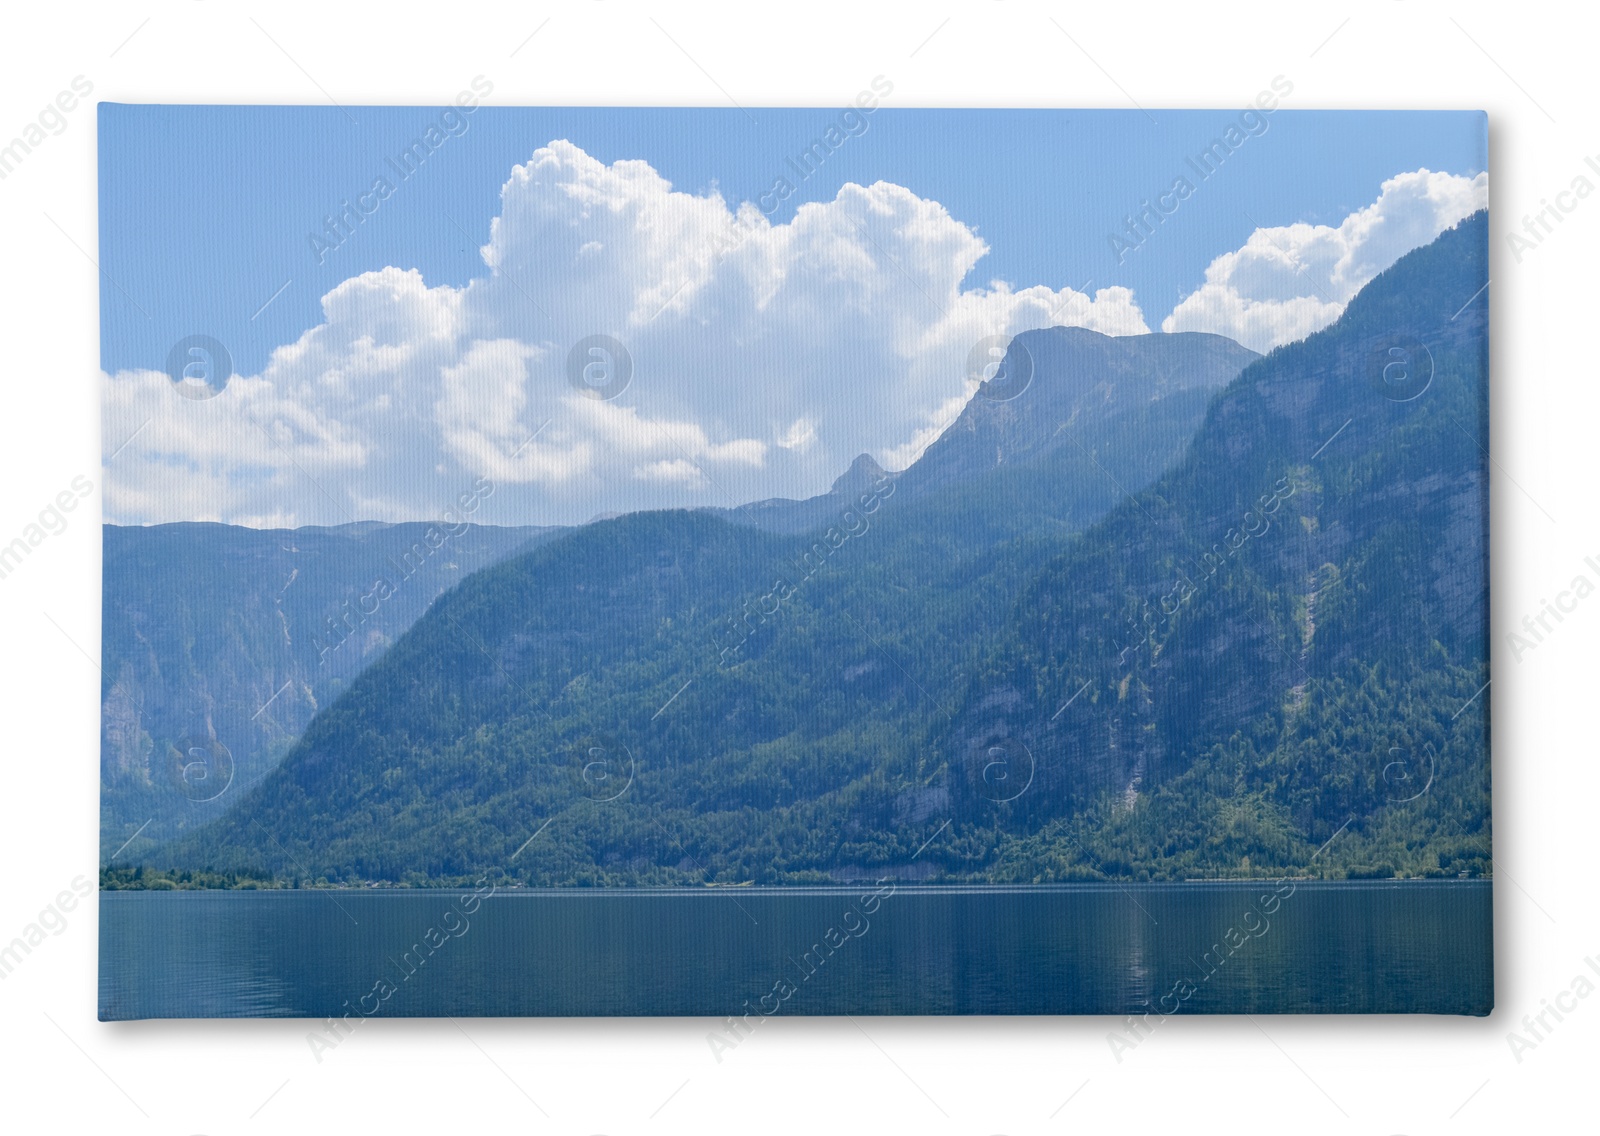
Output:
(99, 102), (1486, 373)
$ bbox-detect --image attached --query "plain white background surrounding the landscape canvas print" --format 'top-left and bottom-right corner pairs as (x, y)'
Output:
(0, 0), (1580, 1134)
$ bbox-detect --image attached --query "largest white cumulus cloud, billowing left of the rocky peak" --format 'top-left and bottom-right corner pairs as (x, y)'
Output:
(104, 141), (1149, 525)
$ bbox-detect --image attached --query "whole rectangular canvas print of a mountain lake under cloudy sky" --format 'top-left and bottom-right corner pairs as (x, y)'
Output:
(93, 95), (1493, 1024)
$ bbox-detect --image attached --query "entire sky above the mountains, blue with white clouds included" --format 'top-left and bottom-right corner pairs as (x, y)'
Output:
(99, 99), (1488, 526)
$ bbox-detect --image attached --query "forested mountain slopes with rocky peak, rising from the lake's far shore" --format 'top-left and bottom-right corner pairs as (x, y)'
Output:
(106, 214), (1490, 885)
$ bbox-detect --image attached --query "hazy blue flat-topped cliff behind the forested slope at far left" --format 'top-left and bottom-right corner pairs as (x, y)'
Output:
(101, 523), (550, 851)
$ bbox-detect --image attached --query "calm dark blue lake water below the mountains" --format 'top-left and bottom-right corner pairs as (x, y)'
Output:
(99, 880), (1493, 1021)
